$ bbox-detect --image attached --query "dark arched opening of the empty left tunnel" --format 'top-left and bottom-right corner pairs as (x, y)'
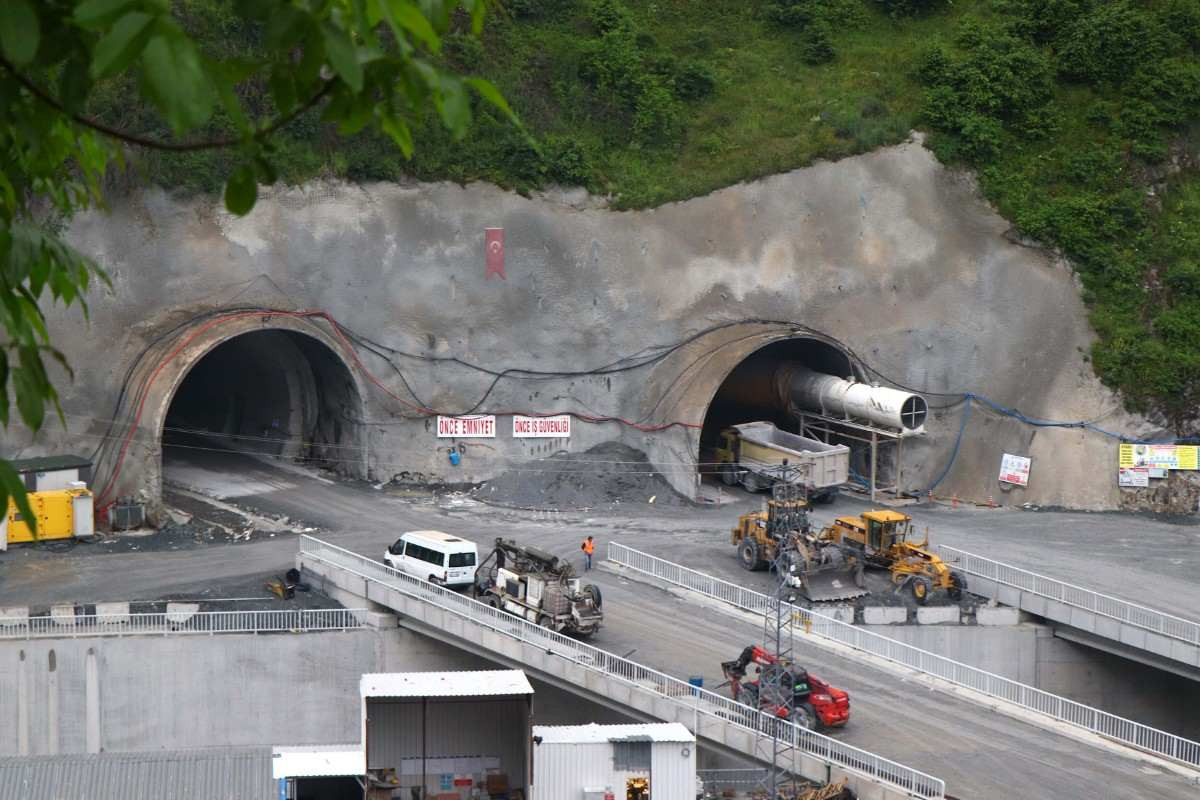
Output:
(162, 330), (362, 474)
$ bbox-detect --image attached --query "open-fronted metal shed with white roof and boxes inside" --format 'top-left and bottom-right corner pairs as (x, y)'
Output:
(360, 669), (533, 800)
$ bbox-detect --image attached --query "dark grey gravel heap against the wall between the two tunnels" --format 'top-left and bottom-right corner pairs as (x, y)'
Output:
(474, 443), (691, 511)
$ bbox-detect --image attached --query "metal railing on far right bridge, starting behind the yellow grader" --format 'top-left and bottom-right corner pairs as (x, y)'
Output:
(937, 545), (1200, 645)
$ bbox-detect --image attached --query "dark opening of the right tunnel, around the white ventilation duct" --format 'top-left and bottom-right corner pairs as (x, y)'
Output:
(700, 338), (863, 496)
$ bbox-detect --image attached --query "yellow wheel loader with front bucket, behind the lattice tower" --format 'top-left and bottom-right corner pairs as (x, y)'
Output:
(730, 494), (868, 602)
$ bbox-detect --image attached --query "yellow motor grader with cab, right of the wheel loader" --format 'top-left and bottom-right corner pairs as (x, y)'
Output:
(817, 510), (967, 606)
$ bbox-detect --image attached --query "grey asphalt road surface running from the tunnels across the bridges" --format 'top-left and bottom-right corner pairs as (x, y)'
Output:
(0, 453), (1200, 800)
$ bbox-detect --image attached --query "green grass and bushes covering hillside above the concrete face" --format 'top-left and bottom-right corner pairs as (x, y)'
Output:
(96, 0), (1200, 434)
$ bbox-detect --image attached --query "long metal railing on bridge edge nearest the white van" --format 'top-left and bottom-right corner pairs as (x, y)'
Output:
(300, 536), (946, 799)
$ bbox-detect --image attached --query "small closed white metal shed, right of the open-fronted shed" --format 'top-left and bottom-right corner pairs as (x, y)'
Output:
(533, 722), (696, 800)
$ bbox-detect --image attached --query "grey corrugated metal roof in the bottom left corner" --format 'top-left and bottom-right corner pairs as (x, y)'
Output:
(0, 747), (278, 800)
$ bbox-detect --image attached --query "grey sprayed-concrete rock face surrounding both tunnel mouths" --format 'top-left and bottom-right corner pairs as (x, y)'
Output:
(16, 142), (1134, 509)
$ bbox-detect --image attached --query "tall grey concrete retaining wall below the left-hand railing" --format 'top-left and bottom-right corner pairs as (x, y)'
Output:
(0, 618), (648, 765)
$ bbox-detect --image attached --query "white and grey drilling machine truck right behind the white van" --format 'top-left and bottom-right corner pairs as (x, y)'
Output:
(474, 537), (604, 637)
